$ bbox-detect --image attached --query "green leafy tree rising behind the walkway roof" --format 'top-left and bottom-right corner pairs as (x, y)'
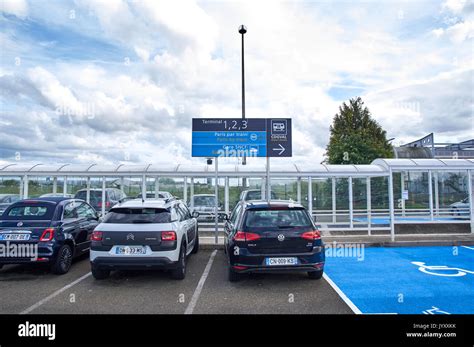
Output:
(326, 97), (393, 164)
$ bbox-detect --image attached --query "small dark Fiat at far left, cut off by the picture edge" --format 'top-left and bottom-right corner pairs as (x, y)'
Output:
(0, 197), (99, 274)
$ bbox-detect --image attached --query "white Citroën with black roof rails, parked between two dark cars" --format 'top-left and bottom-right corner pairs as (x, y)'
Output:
(90, 199), (199, 279)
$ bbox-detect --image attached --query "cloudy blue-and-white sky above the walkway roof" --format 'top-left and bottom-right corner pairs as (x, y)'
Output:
(0, 0), (474, 169)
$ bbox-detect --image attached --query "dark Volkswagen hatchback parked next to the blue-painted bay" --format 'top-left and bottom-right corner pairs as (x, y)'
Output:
(224, 201), (325, 281)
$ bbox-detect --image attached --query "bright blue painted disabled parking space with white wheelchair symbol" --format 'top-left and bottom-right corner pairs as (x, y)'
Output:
(325, 246), (474, 314)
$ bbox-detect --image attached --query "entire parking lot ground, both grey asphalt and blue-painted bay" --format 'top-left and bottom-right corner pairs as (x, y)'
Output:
(0, 246), (474, 314)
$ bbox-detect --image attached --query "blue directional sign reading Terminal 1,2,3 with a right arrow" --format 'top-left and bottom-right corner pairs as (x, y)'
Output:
(192, 118), (292, 157)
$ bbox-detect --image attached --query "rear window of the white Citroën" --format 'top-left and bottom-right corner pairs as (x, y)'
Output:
(103, 207), (171, 224)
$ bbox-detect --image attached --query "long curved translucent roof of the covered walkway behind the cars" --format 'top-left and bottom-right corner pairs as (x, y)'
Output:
(0, 159), (474, 177)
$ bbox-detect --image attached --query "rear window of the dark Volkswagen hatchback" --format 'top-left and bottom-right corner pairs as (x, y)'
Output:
(244, 208), (312, 230)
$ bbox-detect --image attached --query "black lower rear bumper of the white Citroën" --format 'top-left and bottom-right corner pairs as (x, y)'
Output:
(91, 257), (178, 270)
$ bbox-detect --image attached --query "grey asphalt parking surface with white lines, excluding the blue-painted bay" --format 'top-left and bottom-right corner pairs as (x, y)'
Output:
(0, 249), (353, 314)
